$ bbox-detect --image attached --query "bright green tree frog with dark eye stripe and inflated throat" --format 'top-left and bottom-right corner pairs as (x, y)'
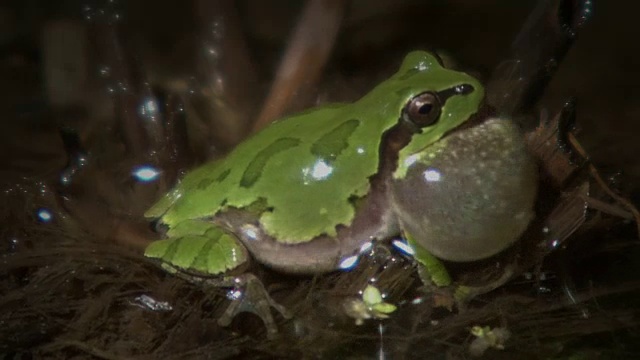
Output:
(145, 50), (537, 334)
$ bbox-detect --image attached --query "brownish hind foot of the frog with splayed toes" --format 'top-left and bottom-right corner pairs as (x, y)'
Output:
(218, 274), (293, 339)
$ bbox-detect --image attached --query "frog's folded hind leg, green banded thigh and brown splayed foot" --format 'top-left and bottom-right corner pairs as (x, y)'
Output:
(145, 220), (291, 337)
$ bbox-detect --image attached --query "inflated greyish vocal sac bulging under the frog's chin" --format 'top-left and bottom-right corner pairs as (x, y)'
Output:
(392, 119), (538, 261)
